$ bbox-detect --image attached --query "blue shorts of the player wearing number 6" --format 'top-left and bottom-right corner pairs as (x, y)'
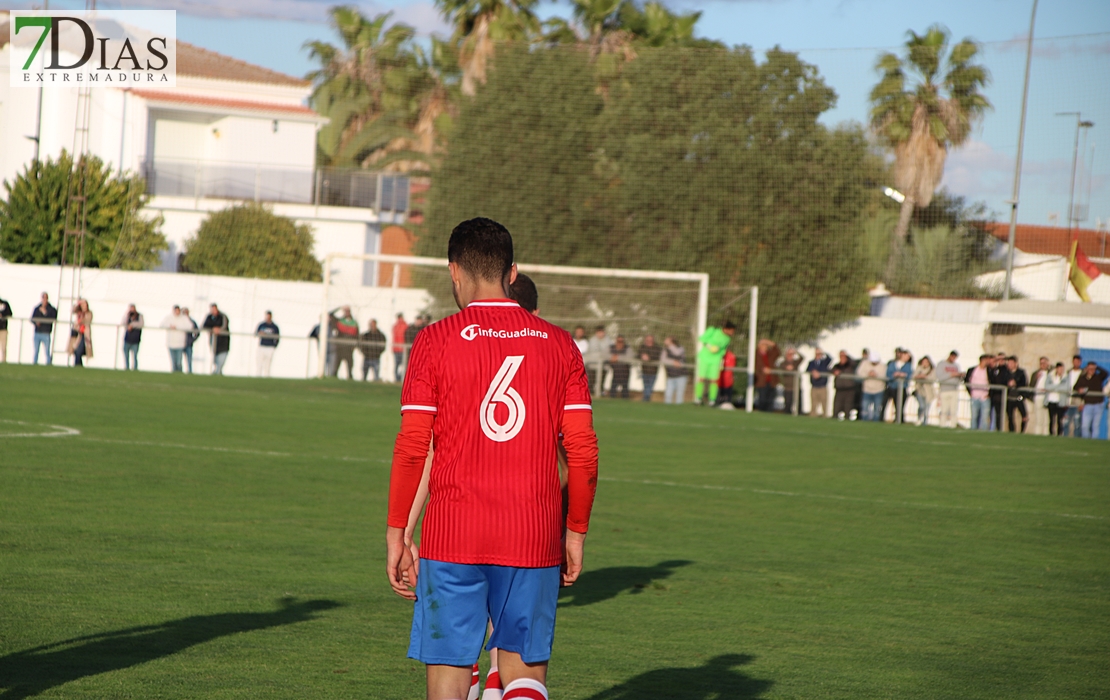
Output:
(408, 559), (559, 666)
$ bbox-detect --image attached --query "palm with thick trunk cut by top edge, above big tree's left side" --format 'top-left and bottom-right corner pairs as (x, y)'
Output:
(435, 0), (539, 95)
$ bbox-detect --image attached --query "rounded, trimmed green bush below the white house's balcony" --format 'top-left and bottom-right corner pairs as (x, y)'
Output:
(182, 202), (322, 282)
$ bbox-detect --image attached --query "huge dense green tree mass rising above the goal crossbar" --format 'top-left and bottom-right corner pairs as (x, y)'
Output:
(418, 47), (881, 339)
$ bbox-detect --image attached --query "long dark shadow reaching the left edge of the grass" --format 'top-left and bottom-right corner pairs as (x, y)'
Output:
(0, 598), (342, 700)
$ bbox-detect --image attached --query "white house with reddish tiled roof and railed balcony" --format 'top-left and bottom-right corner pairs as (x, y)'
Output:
(0, 19), (410, 285)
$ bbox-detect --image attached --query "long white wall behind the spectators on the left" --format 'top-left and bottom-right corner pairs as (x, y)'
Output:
(0, 261), (428, 378)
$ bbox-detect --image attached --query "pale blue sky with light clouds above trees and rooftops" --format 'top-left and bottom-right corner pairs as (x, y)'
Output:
(10, 0), (1110, 227)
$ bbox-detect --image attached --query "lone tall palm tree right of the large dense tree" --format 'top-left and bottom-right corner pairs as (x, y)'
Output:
(870, 24), (991, 278)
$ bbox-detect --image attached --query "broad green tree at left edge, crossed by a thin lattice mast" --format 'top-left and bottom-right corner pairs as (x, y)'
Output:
(0, 151), (169, 270)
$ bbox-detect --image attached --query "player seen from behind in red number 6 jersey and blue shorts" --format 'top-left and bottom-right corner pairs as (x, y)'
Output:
(386, 219), (597, 700)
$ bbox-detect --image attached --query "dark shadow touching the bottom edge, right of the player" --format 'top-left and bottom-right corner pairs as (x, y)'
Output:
(588, 653), (774, 700)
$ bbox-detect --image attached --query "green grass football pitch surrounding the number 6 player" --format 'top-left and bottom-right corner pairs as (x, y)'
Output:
(0, 366), (1110, 700)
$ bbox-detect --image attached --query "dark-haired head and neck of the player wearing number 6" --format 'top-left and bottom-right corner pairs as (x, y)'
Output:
(447, 217), (513, 307)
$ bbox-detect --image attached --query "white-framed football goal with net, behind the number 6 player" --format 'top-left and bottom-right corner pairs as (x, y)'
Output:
(316, 253), (709, 386)
